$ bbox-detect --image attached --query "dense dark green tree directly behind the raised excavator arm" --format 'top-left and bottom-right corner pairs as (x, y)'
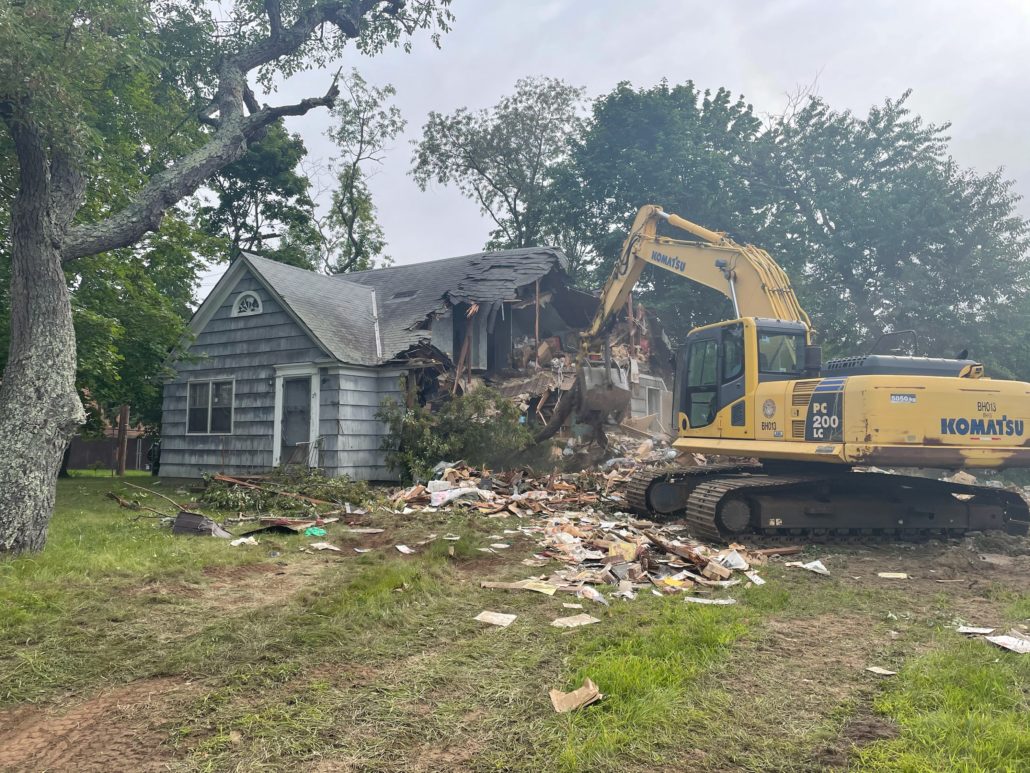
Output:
(555, 80), (763, 338)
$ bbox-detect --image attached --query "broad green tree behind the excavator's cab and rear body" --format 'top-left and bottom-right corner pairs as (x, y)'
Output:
(755, 93), (1030, 375)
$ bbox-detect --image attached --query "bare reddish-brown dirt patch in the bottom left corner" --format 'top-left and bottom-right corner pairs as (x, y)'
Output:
(0, 678), (192, 773)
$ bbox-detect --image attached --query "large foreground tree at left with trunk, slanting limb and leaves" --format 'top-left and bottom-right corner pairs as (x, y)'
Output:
(0, 0), (451, 552)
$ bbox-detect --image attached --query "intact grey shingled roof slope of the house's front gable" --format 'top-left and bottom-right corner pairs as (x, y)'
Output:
(243, 254), (381, 365)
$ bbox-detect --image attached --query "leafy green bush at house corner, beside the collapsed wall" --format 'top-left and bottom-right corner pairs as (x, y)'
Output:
(376, 389), (534, 480)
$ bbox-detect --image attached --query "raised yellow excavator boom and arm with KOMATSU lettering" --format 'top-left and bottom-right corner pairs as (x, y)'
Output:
(584, 204), (811, 341)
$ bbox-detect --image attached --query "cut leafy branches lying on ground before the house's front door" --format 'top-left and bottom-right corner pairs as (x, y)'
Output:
(201, 467), (373, 512)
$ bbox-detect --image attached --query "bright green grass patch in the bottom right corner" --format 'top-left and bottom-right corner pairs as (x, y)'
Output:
(858, 634), (1030, 772)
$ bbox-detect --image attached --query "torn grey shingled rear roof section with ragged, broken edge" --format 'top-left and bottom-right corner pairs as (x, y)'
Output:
(346, 247), (569, 357)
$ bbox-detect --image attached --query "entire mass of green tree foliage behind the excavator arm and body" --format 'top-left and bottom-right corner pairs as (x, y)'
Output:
(552, 82), (1030, 377)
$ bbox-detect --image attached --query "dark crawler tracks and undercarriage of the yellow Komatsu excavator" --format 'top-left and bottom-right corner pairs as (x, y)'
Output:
(627, 465), (1030, 542)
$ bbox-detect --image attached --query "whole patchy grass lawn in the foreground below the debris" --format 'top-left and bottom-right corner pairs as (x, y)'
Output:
(0, 477), (1030, 773)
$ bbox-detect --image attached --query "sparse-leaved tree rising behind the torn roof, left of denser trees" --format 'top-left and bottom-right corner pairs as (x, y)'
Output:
(411, 78), (583, 249)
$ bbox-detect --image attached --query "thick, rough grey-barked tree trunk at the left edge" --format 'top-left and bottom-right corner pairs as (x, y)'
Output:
(0, 125), (85, 553)
